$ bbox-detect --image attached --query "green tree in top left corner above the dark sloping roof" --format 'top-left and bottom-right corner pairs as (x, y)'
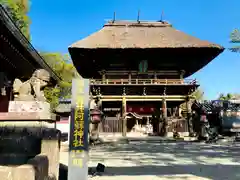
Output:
(0, 0), (30, 39)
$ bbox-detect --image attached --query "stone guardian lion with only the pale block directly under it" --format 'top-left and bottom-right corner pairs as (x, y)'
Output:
(8, 69), (51, 122)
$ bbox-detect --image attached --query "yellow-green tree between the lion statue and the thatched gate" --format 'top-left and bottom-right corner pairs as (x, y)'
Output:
(40, 52), (77, 109)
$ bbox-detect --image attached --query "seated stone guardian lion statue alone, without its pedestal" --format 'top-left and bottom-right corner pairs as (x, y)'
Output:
(13, 69), (50, 101)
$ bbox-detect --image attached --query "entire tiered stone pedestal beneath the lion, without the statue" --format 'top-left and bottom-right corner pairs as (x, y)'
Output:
(0, 102), (61, 180)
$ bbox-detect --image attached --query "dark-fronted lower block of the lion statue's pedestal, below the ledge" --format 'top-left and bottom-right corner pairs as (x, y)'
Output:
(0, 127), (61, 180)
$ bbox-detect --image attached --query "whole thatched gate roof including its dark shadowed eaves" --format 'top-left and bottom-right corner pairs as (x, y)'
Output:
(68, 21), (224, 79)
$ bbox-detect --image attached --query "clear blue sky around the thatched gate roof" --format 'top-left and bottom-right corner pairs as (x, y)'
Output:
(29, 0), (240, 99)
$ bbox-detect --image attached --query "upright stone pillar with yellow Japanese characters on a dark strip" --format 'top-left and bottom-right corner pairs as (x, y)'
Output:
(68, 79), (89, 180)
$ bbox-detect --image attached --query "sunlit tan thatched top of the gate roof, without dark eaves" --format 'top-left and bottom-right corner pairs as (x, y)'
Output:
(70, 21), (222, 49)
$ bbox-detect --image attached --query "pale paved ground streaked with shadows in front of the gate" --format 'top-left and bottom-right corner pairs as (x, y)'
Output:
(61, 140), (240, 180)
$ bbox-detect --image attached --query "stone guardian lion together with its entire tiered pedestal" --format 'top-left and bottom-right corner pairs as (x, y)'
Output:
(0, 69), (61, 180)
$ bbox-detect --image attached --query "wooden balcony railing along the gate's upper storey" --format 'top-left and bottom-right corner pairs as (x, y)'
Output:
(91, 79), (197, 85)
